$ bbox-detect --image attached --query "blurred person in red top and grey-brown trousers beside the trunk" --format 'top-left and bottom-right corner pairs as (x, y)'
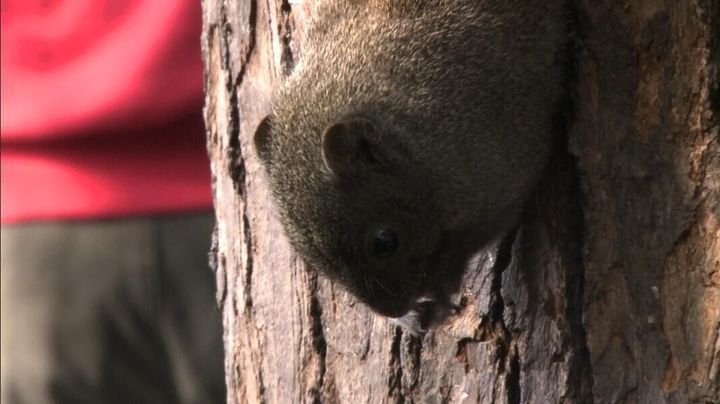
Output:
(0, 0), (225, 404)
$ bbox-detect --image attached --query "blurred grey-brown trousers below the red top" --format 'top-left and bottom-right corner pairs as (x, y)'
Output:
(1, 213), (225, 404)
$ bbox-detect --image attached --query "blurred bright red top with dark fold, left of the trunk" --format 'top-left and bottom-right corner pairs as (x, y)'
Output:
(0, 0), (211, 223)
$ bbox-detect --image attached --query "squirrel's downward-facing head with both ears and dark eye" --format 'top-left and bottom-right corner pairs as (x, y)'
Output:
(254, 115), (442, 317)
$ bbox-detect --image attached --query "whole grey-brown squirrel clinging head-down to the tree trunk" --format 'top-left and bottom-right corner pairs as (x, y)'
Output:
(254, 0), (569, 332)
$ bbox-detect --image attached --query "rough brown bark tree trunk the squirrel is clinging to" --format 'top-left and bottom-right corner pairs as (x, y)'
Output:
(202, 0), (720, 403)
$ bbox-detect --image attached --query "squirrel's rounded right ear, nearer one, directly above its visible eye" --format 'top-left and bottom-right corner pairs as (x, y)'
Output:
(322, 118), (380, 175)
